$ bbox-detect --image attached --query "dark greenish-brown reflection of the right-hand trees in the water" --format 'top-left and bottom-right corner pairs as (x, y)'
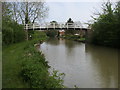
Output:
(86, 45), (118, 87)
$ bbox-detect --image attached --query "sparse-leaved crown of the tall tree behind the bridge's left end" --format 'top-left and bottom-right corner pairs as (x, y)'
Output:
(11, 1), (48, 24)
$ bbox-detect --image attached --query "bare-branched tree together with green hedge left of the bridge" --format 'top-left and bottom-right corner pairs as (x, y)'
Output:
(2, 2), (48, 45)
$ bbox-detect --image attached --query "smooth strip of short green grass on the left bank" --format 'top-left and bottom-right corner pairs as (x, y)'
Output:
(2, 42), (28, 88)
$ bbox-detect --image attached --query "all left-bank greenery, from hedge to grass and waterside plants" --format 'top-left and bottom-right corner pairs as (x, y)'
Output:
(2, 3), (64, 89)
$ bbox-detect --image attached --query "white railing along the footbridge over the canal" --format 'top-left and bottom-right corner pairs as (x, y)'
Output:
(25, 21), (87, 30)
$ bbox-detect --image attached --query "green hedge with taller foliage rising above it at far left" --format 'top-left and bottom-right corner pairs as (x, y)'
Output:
(2, 2), (25, 45)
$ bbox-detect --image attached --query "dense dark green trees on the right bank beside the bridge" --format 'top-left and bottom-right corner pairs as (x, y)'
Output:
(90, 2), (120, 47)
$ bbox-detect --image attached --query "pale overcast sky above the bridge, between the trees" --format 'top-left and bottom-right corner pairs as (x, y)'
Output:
(46, 0), (116, 23)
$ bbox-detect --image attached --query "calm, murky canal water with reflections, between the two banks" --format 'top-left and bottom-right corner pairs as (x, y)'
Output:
(40, 38), (118, 88)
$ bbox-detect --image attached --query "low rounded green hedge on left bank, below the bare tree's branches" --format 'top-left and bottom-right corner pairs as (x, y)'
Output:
(2, 21), (25, 45)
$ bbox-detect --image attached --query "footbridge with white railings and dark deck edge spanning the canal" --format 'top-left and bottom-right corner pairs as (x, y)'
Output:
(25, 22), (90, 31)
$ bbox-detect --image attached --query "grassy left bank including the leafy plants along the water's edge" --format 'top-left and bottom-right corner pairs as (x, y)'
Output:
(3, 32), (64, 88)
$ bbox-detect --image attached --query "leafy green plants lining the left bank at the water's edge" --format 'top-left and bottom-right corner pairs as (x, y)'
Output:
(21, 32), (64, 89)
